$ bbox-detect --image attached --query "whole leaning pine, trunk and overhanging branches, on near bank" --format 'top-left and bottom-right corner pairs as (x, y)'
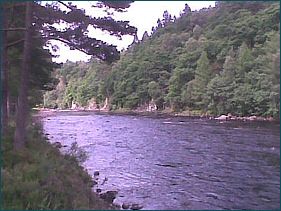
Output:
(10, 2), (136, 150)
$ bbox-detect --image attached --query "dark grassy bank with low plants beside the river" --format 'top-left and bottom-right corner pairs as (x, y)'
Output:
(1, 120), (114, 210)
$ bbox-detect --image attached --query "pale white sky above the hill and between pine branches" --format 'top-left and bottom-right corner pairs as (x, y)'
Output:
(49, 1), (215, 63)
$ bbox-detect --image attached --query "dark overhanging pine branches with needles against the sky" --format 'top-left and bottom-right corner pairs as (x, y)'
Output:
(34, 1), (136, 62)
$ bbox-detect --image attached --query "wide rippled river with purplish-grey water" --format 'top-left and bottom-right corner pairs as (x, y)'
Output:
(43, 112), (280, 210)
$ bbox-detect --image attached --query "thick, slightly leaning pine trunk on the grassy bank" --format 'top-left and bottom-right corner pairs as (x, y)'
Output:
(14, 1), (32, 151)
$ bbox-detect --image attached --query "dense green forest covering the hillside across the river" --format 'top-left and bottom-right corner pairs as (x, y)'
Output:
(41, 1), (280, 118)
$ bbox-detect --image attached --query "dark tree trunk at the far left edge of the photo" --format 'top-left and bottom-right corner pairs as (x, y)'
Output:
(1, 2), (8, 135)
